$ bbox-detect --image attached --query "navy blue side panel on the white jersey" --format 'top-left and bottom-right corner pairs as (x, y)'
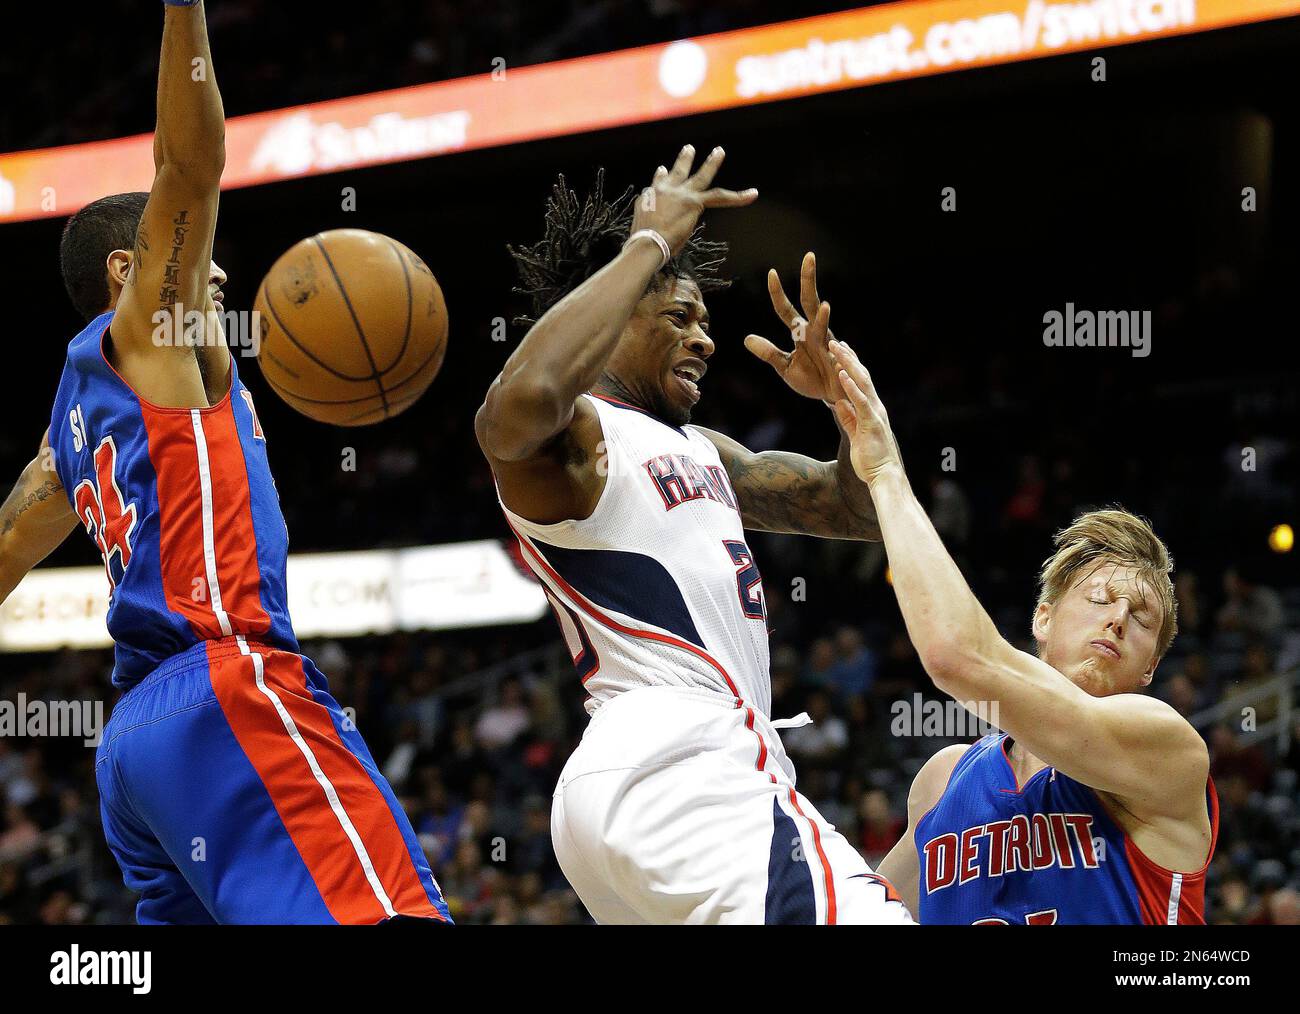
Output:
(529, 537), (705, 647)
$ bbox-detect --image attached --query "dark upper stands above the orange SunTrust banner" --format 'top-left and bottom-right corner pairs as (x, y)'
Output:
(0, 0), (871, 151)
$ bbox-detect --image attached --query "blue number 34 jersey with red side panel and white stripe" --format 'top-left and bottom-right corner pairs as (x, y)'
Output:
(49, 311), (298, 688)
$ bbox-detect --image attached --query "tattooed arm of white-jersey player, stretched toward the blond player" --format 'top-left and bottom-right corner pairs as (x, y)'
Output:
(723, 441), (880, 542)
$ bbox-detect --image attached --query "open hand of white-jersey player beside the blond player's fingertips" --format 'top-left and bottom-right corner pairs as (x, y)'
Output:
(745, 252), (844, 406)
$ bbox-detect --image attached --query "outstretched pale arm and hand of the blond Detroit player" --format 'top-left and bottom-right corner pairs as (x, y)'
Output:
(831, 342), (1209, 818)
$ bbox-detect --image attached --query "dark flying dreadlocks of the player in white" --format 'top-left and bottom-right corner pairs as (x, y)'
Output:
(506, 169), (731, 326)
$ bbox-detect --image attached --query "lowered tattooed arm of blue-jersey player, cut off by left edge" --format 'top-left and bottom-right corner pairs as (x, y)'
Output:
(0, 433), (77, 602)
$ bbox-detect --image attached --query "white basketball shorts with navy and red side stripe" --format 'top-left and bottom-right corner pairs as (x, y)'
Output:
(551, 686), (913, 924)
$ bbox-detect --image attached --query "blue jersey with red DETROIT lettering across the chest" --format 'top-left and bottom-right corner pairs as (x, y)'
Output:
(915, 733), (1218, 926)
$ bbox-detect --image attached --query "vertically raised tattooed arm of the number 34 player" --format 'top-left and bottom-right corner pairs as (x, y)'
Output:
(111, 3), (229, 407)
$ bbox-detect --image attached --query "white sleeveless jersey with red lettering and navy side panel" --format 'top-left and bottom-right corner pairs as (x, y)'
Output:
(498, 395), (771, 715)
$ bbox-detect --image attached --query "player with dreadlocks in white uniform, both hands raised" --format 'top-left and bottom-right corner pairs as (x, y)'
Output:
(475, 146), (910, 923)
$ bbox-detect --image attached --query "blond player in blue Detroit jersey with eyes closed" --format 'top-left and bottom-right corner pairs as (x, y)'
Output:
(829, 341), (1218, 924)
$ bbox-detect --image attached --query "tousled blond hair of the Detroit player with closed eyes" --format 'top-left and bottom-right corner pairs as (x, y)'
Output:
(1039, 507), (1178, 658)
